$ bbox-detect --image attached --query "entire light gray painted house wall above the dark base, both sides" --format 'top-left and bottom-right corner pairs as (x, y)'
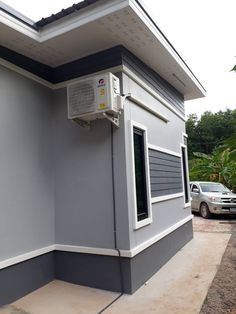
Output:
(0, 63), (190, 259)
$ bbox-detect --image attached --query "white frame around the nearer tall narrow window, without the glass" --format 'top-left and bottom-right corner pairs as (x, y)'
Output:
(130, 120), (153, 230)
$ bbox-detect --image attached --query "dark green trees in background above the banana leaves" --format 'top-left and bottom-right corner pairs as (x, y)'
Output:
(186, 109), (236, 159)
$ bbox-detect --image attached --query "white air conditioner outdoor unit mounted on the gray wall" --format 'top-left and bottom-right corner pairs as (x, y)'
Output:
(67, 73), (122, 126)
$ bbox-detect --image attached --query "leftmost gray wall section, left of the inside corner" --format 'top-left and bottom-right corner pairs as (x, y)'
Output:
(0, 66), (54, 260)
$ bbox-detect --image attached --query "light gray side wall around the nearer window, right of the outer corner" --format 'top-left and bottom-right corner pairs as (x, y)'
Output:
(123, 75), (191, 249)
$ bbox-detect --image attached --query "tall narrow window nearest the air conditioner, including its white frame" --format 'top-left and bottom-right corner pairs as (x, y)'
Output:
(131, 122), (152, 229)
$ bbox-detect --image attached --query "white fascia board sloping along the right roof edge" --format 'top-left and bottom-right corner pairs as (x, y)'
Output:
(129, 0), (206, 96)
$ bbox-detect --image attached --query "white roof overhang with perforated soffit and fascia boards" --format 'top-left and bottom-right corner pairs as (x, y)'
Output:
(0, 0), (205, 100)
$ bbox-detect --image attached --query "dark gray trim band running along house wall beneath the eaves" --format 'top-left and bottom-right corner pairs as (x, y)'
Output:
(0, 46), (184, 115)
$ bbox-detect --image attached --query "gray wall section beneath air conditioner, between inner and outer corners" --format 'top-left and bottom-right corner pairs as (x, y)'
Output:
(53, 88), (129, 248)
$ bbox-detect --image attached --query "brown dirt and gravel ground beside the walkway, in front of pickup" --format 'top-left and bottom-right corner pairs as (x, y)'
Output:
(194, 216), (236, 314)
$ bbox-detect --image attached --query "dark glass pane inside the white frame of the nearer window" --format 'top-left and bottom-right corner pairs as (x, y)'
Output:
(133, 127), (148, 221)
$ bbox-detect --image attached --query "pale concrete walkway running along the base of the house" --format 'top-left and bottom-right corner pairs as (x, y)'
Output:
(0, 222), (230, 314)
